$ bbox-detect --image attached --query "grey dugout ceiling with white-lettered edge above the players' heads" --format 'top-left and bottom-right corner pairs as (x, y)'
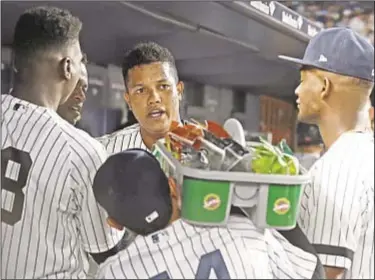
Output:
(1, 1), (324, 97)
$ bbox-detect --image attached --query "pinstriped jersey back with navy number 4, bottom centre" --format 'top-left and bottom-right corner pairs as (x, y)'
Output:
(97, 216), (316, 279)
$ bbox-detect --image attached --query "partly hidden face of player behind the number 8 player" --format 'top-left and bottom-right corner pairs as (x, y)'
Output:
(57, 55), (88, 125)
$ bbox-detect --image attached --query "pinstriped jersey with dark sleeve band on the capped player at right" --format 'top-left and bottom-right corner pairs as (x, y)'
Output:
(299, 132), (374, 279)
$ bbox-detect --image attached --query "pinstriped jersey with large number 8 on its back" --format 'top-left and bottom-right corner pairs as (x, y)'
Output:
(1, 95), (125, 279)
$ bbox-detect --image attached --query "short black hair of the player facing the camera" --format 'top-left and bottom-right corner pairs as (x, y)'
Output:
(122, 42), (178, 86)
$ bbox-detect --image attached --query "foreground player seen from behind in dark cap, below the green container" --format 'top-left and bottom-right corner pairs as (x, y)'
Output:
(93, 149), (317, 279)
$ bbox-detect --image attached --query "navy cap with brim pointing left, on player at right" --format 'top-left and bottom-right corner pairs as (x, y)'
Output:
(279, 27), (374, 82)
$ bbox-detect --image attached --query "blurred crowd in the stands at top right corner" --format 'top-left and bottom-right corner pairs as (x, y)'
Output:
(282, 1), (374, 44)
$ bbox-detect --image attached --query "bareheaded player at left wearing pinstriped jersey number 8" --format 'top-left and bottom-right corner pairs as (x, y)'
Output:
(1, 7), (121, 279)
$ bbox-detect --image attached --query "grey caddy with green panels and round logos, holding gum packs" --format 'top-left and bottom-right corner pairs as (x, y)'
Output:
(153, 140), (310, 230)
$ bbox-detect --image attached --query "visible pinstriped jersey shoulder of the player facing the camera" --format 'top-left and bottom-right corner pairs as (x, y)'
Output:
(97, 124), (148, 154)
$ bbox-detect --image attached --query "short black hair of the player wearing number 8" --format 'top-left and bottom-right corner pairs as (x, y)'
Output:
(13, 6), (82, 66)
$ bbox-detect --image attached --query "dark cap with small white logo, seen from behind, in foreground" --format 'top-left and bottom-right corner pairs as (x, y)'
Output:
(93, 149), (172, 235)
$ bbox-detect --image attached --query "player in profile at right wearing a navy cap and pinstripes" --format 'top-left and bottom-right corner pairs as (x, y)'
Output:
(281, 28), (374, 279)
